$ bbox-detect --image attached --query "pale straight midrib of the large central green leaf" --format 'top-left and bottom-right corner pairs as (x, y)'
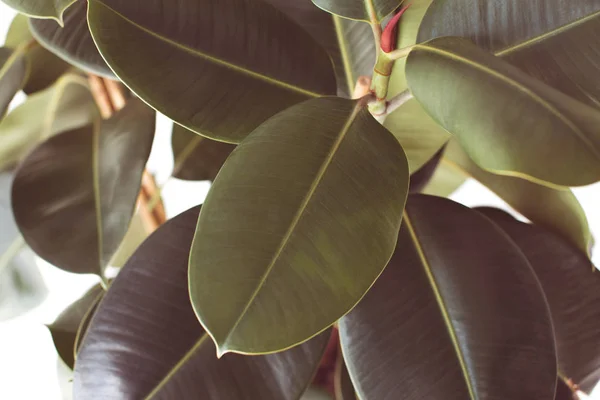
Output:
(219, 102), (363, 354)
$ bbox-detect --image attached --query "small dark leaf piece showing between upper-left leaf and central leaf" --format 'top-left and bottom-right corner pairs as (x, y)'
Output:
(171, 124), (235, 181)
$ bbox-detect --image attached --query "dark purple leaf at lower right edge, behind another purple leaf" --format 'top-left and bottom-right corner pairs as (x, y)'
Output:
(478, 209), (600, 392)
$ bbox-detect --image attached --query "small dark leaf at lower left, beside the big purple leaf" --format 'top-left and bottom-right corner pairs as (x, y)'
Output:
(48, 285), (104, 369)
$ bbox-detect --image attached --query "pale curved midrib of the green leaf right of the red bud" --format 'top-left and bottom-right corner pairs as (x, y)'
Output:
(414, 43), (600, 162)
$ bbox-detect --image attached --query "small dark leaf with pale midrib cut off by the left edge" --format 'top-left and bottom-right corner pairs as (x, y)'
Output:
(0, 46), (28, 118)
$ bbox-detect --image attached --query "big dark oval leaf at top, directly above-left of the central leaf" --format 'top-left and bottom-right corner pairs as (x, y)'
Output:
(88, 0), (336, 143)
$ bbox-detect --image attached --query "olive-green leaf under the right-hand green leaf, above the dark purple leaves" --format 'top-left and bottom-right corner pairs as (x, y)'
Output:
(442, 140), (592, 254)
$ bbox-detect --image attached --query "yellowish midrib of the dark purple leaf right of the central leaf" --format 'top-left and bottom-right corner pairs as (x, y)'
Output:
(404, 211), (477, 400)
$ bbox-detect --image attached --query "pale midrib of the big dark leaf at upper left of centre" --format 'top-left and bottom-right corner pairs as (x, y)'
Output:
(90, 0), (325, 98)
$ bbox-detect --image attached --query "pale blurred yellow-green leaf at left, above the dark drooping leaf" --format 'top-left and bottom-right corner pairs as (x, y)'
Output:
(0, 74), (98, 170)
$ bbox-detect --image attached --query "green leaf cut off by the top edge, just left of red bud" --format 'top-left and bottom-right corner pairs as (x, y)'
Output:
(312, 0), (402, 22)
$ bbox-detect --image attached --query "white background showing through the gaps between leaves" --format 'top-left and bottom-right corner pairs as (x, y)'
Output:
(0, 2), (600, 400)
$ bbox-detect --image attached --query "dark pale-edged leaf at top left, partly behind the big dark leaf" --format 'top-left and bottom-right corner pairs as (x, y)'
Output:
(30, 1), (114, 78)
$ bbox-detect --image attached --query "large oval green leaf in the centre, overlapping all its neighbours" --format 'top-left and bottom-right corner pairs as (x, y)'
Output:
(190, 98), (408, 354)
